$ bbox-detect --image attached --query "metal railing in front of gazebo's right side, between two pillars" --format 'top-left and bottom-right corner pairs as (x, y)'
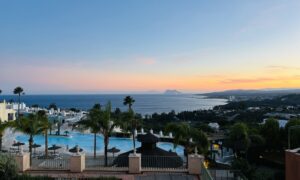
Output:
(141, 156), (187, 172)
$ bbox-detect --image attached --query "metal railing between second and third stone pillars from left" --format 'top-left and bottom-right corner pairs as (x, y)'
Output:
(85, 156), (128, 171)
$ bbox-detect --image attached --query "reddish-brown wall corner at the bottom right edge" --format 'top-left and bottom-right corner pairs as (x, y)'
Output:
(285, 148), (300, 180)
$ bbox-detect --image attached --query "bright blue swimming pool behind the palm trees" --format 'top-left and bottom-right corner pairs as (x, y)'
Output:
(16, 132), (183, 155)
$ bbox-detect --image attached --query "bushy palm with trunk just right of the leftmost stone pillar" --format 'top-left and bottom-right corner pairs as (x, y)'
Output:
(15, 113), (44, 165)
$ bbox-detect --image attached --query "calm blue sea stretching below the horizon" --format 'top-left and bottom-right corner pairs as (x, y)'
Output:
(0, 94), (227, 115)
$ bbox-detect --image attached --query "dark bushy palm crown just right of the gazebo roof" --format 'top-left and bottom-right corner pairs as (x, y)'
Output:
(166, 123), (208, 160)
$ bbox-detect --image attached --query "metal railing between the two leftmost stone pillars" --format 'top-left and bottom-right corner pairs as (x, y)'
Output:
(30, 158), (70, 170)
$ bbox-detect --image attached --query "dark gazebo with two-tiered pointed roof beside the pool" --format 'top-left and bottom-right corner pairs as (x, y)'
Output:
(114, 133), (183, 168)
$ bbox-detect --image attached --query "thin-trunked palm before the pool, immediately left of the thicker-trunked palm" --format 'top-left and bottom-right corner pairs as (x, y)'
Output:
(76, 104), (101, 158)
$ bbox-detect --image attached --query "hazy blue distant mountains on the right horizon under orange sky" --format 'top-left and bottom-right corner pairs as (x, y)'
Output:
(201, 89), (300, 100)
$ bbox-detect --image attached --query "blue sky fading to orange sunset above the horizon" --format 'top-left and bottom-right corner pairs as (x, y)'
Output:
(0, 0), (300, 94)
